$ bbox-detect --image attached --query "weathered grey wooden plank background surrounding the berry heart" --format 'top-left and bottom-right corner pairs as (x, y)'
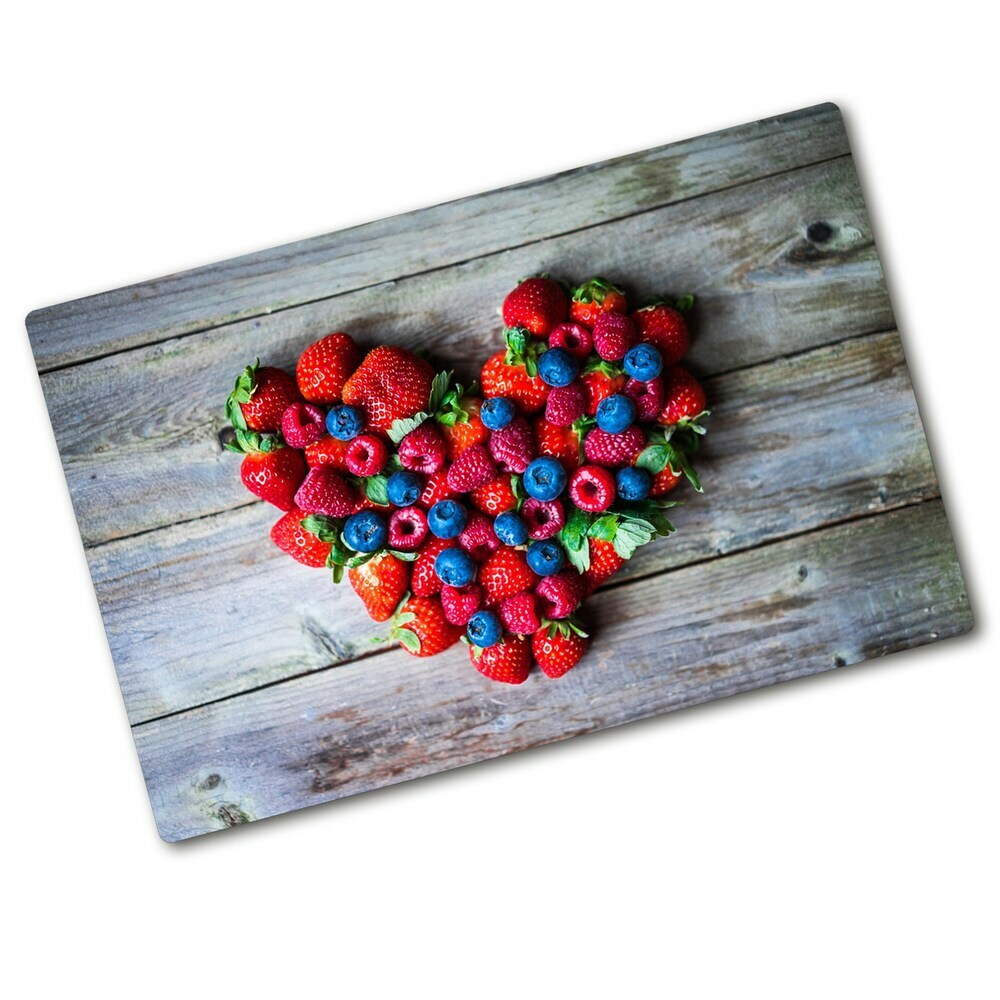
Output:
(28, 105), (972, 840)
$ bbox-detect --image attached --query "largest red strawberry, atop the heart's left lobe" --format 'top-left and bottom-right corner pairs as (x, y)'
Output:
(343, 345), (434, 431)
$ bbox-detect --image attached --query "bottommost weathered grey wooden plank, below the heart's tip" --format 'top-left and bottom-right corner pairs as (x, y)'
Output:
(134, 501), (971, 840)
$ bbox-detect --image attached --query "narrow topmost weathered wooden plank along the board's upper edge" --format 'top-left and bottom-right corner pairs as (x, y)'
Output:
(28, 104), (848, 371)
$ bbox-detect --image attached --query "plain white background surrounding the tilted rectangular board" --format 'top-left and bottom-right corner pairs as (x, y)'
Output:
(0, 2), (1000, 998)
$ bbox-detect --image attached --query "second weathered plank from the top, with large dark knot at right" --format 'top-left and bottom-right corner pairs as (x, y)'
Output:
(42, 157), (893, 545)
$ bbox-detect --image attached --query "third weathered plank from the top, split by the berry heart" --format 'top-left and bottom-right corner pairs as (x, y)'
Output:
(95, 332), (938, 723)
